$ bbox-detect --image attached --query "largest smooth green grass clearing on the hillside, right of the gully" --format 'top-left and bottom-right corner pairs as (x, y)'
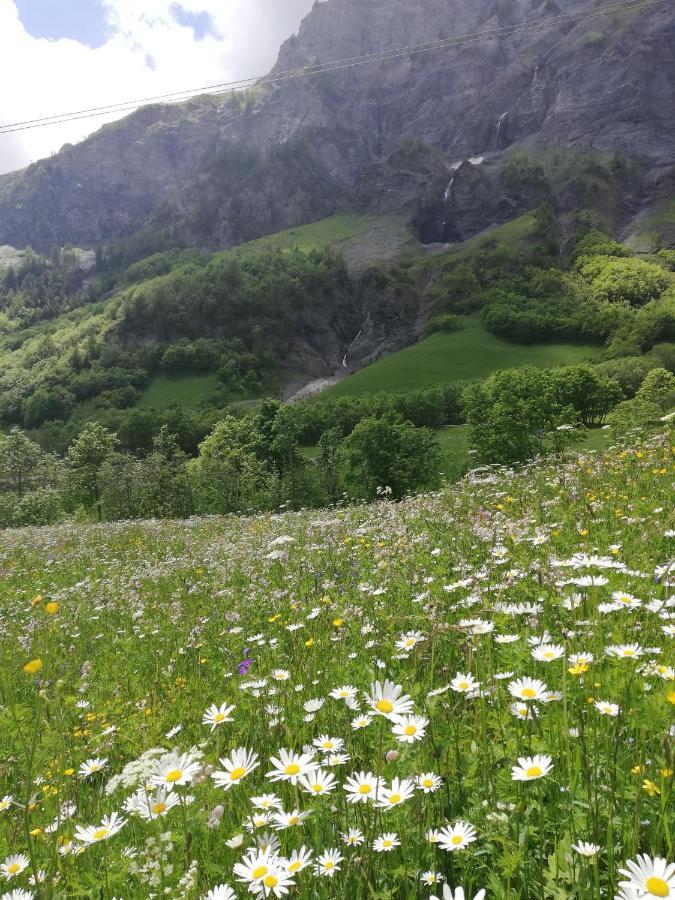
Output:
(320, 317), (601, 397)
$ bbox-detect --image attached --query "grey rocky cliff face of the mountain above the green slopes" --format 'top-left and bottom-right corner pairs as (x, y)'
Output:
(0, 0), (675, 249)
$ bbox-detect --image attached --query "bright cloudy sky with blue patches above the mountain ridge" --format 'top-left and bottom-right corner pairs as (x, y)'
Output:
(0, 0), (314, 174)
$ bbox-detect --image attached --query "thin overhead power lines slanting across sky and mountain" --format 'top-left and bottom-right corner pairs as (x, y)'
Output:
(0, 0), (667, 135)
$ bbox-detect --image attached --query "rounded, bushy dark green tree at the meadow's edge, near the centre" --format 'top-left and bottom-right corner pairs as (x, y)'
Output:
(341, 416), (442, 500)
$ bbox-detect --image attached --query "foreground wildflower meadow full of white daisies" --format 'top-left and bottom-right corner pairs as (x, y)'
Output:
(0, 434), (675, 900)
